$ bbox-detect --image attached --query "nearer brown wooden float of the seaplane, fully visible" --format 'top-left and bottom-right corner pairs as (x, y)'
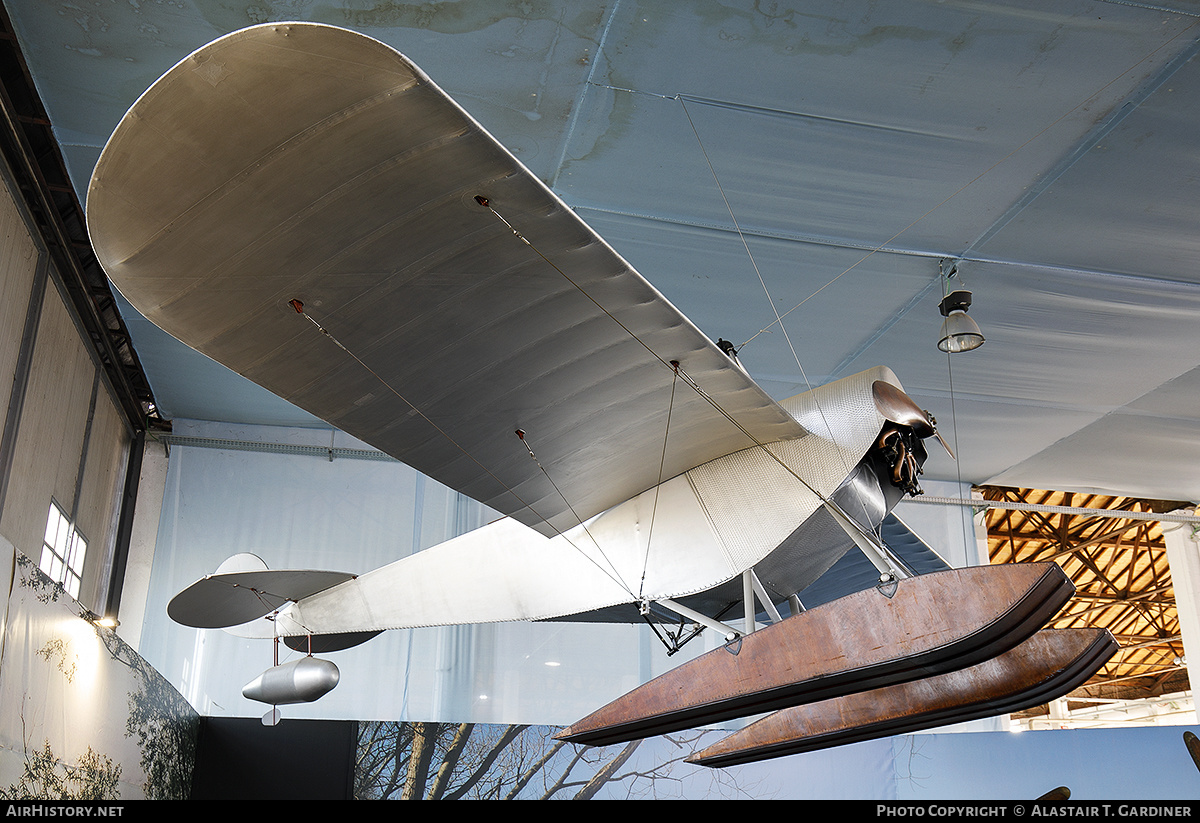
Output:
(557, 563), (1075, 746)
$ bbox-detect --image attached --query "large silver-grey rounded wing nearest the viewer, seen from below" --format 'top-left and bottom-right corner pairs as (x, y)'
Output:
(88, 23), (805, 535)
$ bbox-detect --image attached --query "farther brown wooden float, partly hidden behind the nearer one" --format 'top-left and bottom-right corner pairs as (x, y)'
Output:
(688, 629), (1118, 768)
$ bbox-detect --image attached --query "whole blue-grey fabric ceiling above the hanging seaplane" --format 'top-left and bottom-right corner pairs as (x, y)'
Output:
(6, 0), (1200, 508)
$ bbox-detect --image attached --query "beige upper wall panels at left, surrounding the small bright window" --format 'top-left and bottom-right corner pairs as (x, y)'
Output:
(0, 163), (132, 612)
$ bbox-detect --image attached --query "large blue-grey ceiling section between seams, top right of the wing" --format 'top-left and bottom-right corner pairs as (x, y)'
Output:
(556, 2), (1190, 251)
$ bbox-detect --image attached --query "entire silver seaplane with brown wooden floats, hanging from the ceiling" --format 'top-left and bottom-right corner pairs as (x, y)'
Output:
(88, 23), (1115, 765)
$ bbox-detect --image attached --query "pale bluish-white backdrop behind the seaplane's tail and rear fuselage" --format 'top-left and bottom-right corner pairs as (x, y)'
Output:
(140, 421), (715, 725)
